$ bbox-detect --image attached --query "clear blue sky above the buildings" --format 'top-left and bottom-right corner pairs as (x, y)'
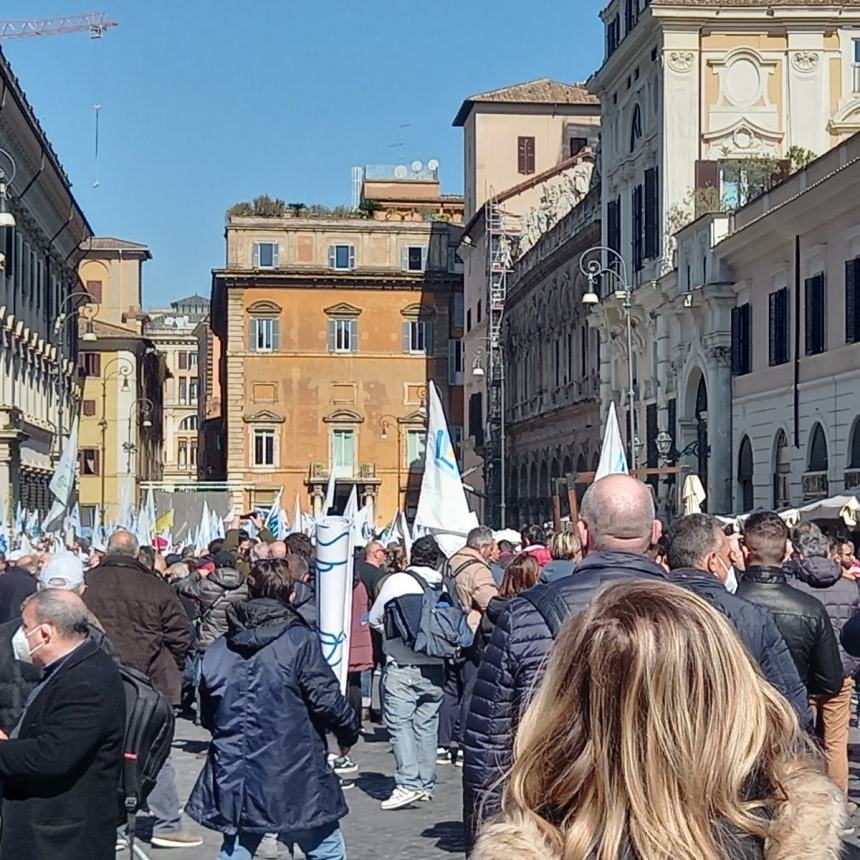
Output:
(2, 0), (603, 307)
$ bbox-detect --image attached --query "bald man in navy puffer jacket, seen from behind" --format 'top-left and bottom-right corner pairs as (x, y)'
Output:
(463, 475), (667, 842)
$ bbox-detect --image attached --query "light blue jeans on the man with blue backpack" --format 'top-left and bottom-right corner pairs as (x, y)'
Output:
(383, 663), (443, 792)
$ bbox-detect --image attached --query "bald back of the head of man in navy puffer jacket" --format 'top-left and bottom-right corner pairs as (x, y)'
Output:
(580, 474), (656, 552)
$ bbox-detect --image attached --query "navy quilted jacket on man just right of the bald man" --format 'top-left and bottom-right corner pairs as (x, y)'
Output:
(669, 569), (812, 726)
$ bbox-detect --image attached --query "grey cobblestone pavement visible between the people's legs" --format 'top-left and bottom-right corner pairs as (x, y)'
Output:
(129, 720), (463, 860)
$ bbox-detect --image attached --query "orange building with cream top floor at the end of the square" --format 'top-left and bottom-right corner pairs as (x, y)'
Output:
(211, 173), (463, 523)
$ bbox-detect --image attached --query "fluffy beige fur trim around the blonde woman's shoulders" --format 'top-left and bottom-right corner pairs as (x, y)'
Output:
(470, 774), (845, 860)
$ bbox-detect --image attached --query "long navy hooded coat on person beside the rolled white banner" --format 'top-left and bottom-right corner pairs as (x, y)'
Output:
(185, 598), (359, 833)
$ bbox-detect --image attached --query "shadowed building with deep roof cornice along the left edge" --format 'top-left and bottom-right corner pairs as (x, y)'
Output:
(0, 50), (92, 522)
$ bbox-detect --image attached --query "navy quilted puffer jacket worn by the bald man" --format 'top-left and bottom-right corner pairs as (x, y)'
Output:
(463, 552), (666, 841)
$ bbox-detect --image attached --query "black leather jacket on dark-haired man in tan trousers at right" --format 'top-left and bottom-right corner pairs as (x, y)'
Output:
(738, 567), (843, 696)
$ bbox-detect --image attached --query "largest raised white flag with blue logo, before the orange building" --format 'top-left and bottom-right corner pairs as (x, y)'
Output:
(415, 380), (478, 558)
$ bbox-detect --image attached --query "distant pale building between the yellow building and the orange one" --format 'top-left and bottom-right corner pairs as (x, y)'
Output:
(143, 295), (209, 484)
